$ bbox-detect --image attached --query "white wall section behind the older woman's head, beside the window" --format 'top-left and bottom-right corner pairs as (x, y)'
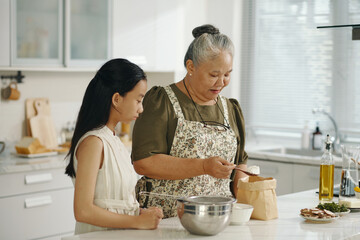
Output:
(176, 0), (242, 100)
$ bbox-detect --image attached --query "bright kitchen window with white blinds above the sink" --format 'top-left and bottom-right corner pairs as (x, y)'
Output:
(240, 0), (360, 140)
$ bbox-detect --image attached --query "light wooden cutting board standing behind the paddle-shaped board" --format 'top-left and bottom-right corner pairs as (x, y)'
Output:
(25, 98), (51, 137)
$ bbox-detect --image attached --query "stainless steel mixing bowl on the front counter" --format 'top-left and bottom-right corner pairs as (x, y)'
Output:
(177, 196), (236, 235)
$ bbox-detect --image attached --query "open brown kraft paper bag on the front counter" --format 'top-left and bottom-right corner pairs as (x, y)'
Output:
(237, 176), (278, 220)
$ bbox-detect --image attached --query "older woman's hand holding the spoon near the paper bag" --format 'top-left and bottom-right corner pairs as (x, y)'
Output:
(203, 157), (236, 179)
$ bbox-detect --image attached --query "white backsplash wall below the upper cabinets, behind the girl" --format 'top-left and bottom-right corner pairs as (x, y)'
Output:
(0, 71), (174, 144)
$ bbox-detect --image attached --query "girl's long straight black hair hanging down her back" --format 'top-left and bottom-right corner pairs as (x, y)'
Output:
(65, 58), (146, 177)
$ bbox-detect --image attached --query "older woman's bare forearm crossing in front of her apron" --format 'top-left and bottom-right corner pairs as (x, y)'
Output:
(133, 154), (205, 180)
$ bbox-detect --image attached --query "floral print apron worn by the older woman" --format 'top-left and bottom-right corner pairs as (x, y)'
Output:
(136, 86), (237, 218)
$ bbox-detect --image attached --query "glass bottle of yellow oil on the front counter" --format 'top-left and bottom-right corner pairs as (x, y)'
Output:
(319, 134), (334, 203)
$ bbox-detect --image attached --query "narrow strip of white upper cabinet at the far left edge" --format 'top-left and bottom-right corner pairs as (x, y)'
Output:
(0, 0), (10, 67)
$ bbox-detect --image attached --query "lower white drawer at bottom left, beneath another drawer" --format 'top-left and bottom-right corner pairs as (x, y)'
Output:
(0, 189), (75, 239)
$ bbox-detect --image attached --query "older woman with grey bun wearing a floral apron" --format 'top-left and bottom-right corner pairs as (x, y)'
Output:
(132, 25), (247, 217)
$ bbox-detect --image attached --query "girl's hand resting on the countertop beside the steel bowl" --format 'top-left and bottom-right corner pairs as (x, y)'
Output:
(138, 207), (164, 229)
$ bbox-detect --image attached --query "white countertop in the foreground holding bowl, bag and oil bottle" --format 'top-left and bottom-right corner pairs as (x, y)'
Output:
(62, 190), (360, 240)
